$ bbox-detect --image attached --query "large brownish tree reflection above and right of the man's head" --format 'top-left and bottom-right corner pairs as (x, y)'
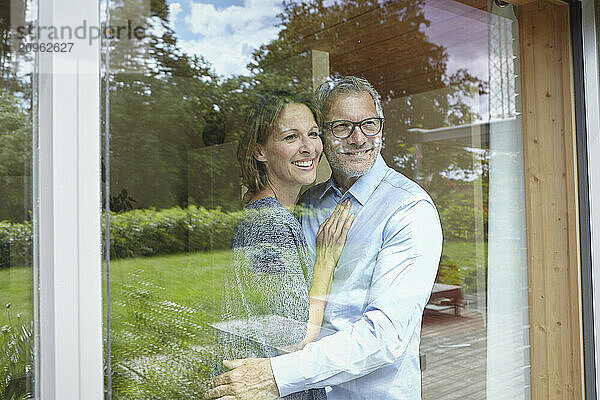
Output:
(251, 0), (487, 239)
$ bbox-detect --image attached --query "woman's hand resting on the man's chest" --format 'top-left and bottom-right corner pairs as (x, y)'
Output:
(315, 200), (354, 272)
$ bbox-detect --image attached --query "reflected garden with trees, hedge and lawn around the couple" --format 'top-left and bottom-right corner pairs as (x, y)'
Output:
(0, 0), (488, 398)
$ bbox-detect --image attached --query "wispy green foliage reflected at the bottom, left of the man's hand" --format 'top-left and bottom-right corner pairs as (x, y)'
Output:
(111, 270), (211, 400)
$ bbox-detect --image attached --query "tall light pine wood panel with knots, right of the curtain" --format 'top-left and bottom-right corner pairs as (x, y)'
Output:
(519, 2), (583, 400)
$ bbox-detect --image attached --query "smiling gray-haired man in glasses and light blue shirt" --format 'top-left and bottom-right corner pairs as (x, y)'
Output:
(207, 76), (442, 400)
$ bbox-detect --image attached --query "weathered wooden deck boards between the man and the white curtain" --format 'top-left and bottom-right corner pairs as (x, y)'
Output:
(421, 309), (486, 400)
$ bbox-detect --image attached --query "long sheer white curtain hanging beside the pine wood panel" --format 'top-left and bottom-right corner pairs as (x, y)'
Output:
(487, 2), (530, 400)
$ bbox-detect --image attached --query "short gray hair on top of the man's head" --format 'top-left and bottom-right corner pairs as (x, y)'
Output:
(315, 76), (383, 118)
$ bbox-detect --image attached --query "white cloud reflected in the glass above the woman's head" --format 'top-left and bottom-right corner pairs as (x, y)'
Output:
(180, 0), (282, 75)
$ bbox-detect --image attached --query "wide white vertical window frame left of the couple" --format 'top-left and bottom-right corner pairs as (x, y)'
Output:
(34, 0), (104, 400)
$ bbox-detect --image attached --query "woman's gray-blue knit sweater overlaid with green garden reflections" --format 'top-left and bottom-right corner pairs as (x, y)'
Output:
(217, 197), (326, 400)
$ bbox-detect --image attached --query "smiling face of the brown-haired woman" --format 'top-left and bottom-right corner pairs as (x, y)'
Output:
(255, 103), (323, 190)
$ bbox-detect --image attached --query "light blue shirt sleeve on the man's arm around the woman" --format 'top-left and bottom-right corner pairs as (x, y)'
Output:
(271, 200), (442, 396)
